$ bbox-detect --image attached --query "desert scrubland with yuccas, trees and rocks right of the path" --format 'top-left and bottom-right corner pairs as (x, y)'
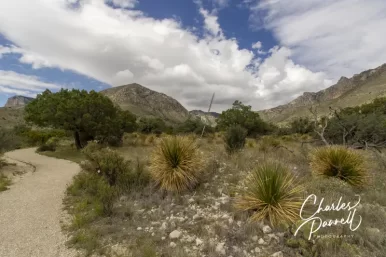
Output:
(0, 90), (386, 257)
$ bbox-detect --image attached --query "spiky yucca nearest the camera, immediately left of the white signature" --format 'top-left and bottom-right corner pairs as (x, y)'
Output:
(235, 161), (303, 226)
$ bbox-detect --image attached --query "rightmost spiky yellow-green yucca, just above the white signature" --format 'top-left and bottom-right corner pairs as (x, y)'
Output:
(311, 146), (368, 187)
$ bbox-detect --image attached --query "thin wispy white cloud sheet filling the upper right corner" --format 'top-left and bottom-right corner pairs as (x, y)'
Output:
(250, 0), (386, 80)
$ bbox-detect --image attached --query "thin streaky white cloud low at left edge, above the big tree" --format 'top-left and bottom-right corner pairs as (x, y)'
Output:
(0, 70), (60, 96)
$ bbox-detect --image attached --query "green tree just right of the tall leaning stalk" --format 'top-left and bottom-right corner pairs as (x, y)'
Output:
(217, 100), (271, 136)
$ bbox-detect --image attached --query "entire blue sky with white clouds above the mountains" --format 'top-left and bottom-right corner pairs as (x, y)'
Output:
(0, 0), (386, 112)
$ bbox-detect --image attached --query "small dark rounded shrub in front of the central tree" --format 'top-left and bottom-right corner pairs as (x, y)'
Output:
(224, 125), (247, 154)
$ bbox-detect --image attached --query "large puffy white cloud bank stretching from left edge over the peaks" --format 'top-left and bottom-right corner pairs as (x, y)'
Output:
(0, 0), (330, 111)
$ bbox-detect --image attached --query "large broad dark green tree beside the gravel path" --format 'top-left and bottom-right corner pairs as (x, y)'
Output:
(25, 89), (136, 149)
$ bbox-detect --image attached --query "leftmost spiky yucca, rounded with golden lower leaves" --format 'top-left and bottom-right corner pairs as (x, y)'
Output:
(150, 136), (202, 192)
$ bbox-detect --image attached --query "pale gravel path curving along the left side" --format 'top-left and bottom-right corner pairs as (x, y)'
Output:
(0, 148), (80, 257)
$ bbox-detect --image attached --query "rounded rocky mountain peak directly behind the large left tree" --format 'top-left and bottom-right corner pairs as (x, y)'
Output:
(100, 83), (189, 123)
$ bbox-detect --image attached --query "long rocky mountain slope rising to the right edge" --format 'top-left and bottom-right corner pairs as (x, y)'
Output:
(258, 64), (386, 124)
